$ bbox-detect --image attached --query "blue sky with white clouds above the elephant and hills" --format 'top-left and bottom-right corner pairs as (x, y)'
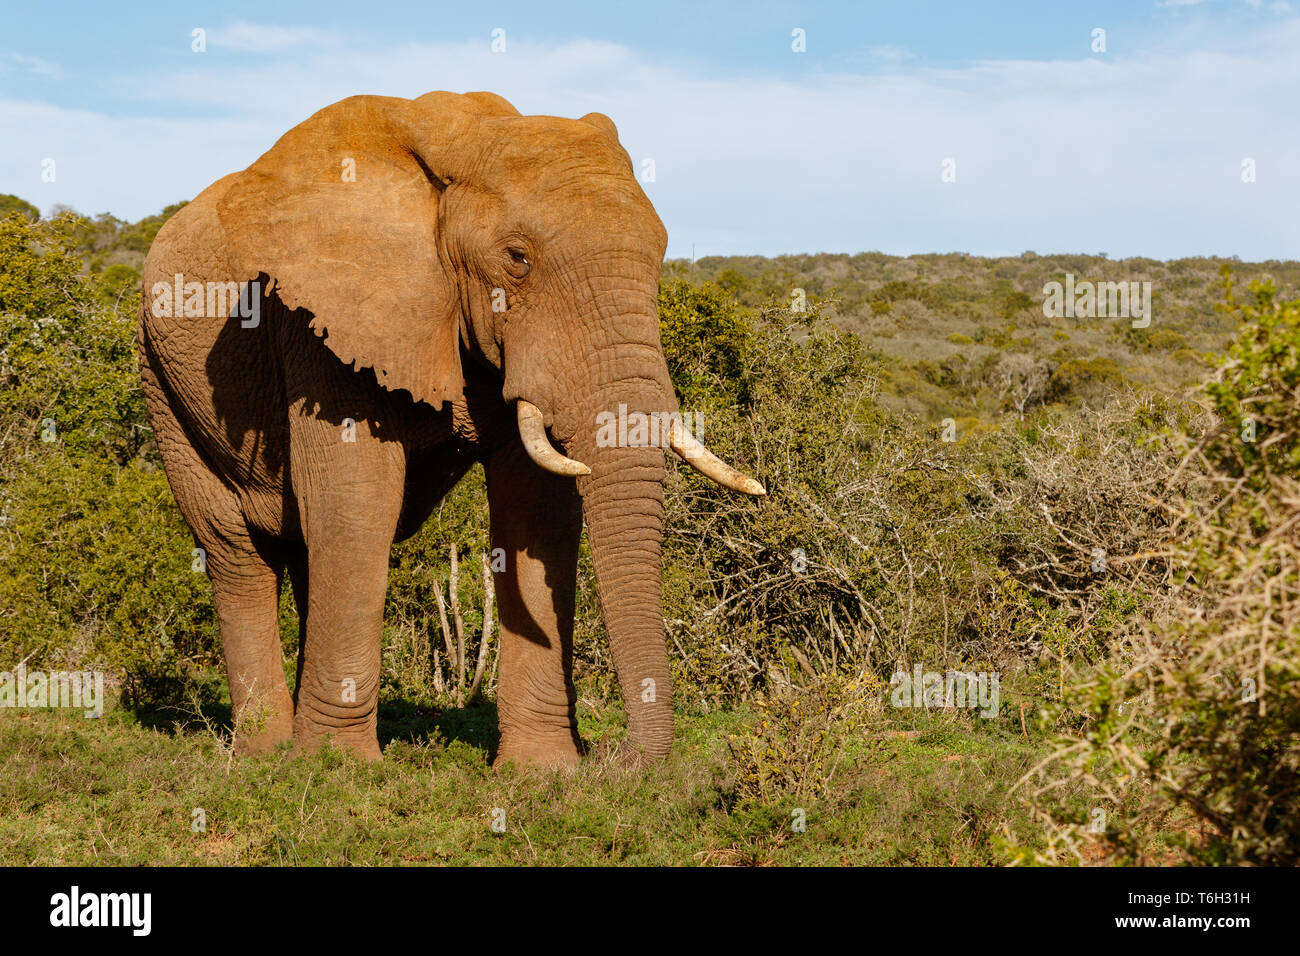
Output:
(0, 0), (1300, 259)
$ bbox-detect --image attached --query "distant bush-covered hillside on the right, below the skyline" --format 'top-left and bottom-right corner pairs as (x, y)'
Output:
(667, 252), (1300, 420)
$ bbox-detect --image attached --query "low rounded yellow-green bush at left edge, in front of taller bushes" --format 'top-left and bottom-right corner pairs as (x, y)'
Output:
(0, 447), (220, 705)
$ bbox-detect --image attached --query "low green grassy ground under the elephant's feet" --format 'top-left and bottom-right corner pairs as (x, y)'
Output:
(0, 686), (1076, 866)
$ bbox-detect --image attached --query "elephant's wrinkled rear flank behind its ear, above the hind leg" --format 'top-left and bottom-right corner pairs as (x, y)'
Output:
(139, 173), (296, 532)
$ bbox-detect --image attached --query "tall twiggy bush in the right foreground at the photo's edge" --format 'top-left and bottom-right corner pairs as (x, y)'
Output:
(1043, 273), (1300, 865)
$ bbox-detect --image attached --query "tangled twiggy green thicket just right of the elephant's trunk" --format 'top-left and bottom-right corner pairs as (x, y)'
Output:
(644, 285), (1162, 709)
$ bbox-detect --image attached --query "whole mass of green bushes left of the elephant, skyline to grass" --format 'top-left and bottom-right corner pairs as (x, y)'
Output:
(0, 215), (217, 704)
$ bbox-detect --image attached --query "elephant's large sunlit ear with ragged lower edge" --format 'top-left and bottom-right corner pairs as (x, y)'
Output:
(217, 94), (478, 407)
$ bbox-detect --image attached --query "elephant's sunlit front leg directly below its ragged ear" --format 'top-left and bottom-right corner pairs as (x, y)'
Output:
(293, 419), (406, 760)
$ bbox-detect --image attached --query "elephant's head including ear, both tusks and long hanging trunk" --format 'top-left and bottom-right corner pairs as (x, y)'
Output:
(220, 92), (763, 756)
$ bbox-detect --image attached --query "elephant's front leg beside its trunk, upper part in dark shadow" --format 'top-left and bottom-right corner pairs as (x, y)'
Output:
(486, 437), (582, 766)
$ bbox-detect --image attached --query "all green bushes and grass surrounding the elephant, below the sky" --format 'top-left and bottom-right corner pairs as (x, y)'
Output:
(0, 198), (1300, 862)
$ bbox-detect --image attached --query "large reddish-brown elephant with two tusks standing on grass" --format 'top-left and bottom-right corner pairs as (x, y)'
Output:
(138, 92), (766, 766)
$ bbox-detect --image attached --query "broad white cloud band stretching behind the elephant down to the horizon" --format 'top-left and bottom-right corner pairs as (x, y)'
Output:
(0, 21), (1300, 259)
